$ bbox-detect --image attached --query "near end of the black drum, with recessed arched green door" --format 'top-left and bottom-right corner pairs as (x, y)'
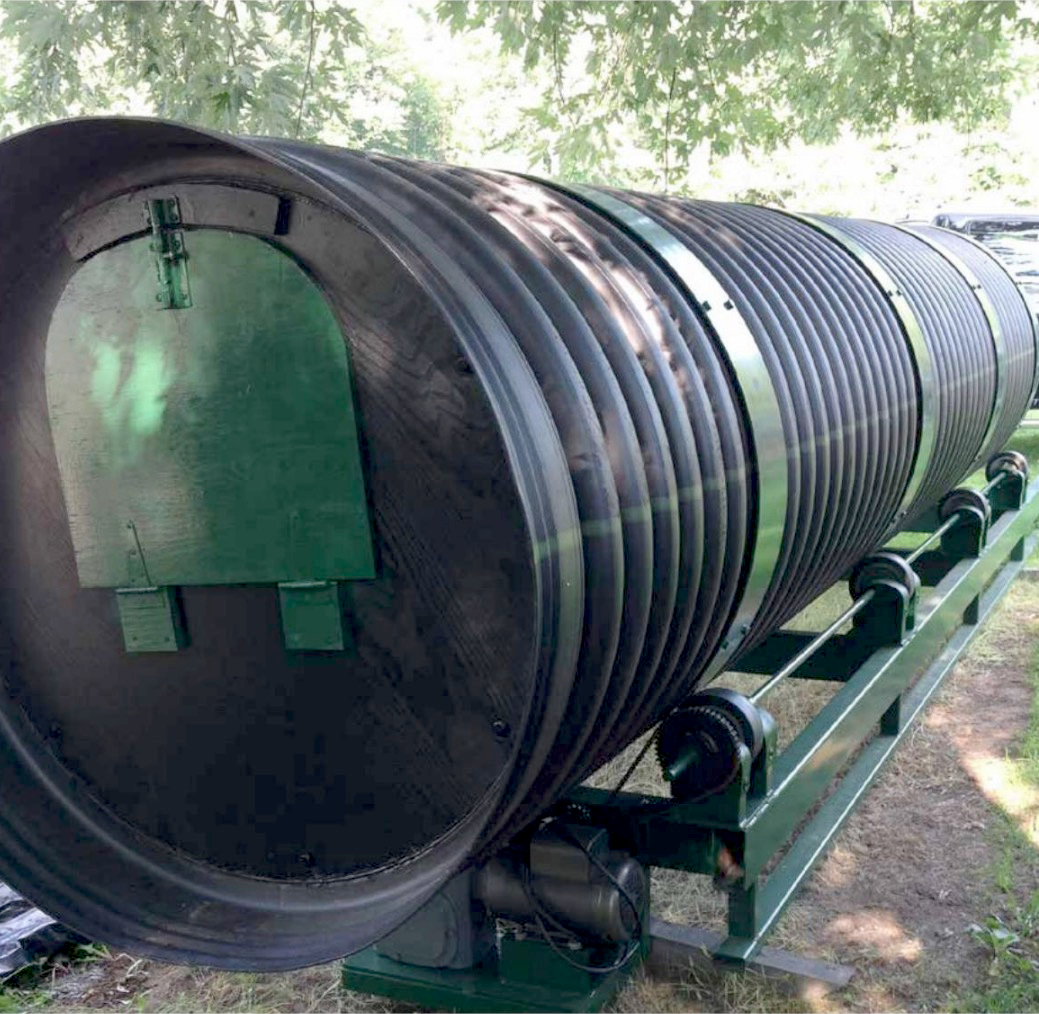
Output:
(0, 118), (561, 967)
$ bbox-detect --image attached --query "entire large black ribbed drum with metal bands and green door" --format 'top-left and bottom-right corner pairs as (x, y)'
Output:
(0, 119), (1037, 968)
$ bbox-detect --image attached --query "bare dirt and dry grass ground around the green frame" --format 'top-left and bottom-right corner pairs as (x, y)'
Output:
(8, 581), (1039, 1012)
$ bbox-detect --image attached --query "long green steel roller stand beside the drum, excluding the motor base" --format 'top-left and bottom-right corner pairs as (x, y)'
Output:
(559, 467), (1039, 963)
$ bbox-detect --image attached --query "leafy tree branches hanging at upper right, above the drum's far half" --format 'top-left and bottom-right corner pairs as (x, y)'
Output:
(438, 0), (1022, 188)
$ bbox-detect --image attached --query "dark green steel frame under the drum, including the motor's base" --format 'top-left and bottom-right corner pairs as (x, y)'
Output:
(344, 470), (1039, 1010)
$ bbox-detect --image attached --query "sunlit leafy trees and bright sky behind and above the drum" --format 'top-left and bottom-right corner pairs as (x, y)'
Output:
(0, 0), (1039, 213)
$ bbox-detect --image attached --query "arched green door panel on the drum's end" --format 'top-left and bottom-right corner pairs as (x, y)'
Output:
(46, 224), (374, 588)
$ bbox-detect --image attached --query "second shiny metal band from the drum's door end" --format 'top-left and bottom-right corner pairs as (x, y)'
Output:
(776, 209), (937, 522)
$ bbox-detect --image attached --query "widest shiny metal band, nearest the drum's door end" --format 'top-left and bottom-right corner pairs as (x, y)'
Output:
(538, 180), (790, 673)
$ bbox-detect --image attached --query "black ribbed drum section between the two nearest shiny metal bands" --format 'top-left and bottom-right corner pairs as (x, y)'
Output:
(615, 197), (917, 638)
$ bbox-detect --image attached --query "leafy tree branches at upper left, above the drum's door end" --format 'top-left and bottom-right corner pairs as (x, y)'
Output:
(0, 0), (438, 144)
